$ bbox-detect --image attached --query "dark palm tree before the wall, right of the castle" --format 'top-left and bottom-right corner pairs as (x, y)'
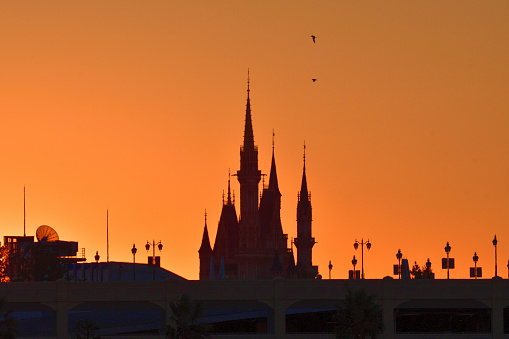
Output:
(334, 289), (383, 339)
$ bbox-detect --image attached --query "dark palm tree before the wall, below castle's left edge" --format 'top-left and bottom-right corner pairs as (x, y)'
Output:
(166, 294), (210, 339)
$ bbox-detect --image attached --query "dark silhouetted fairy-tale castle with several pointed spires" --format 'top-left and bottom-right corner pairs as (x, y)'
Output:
(198, 76), (318, 280)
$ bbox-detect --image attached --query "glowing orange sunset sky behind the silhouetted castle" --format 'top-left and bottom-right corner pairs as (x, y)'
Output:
(0, 0), (509, 279)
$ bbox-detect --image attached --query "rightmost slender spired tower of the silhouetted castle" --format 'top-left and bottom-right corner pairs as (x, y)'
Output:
(294, 144), (318, 279)
